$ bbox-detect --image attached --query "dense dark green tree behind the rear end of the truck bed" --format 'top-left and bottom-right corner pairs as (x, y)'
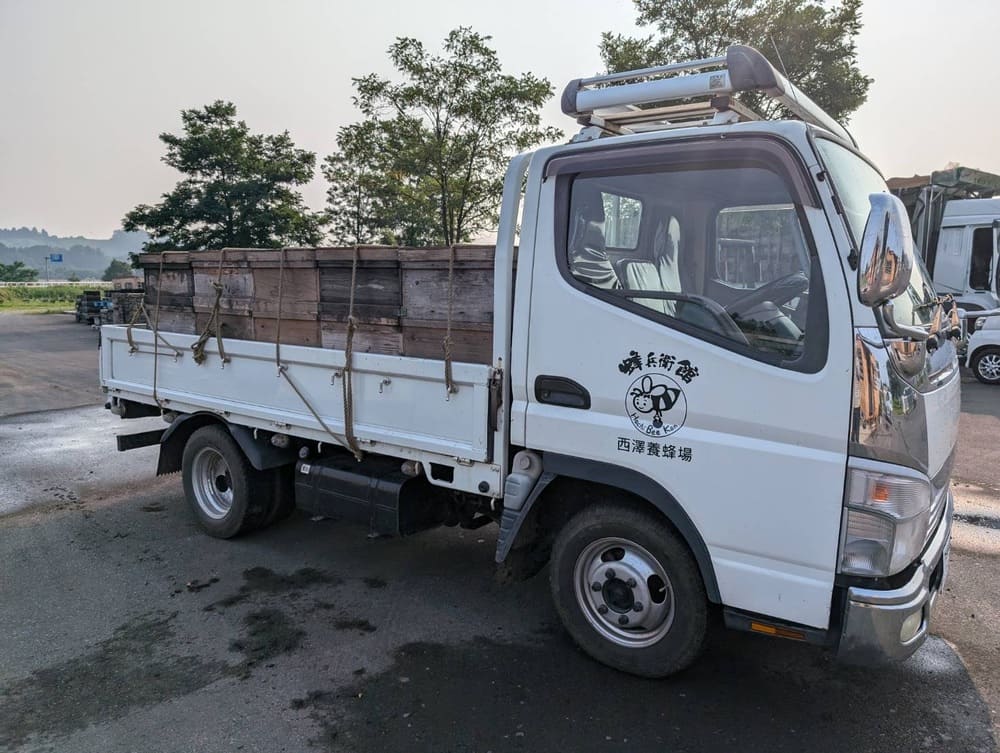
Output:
(122, 100), (326, 251)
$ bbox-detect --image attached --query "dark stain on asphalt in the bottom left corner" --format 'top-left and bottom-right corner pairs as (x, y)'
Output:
(0, 615), (225, 749)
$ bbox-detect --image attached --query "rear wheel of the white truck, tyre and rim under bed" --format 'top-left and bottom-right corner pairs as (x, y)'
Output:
(181, 426), (271, 539)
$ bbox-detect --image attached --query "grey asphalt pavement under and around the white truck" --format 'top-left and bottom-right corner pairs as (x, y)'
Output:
(0, 315), (1000, 753)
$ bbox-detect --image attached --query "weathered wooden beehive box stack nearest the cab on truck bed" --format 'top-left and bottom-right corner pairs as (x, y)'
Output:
(399, 246), (496, 364)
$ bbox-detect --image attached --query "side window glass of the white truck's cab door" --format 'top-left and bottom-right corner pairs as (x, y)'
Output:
(564, 165), (812, 363)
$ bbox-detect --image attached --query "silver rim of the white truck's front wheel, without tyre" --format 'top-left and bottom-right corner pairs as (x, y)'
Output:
(573, 538), (674, 648)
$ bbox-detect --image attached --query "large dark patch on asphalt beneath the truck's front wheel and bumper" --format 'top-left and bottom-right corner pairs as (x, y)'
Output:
(292, 633), (996, 753)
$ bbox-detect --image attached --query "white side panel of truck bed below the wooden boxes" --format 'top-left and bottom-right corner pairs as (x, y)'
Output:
(101, 326), (491, 462)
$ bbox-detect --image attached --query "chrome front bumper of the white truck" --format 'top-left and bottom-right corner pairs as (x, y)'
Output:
(837, 490), (953, 664)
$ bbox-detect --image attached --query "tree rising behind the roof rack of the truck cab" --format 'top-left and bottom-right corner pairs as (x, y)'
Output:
(600, 0), (872, 121)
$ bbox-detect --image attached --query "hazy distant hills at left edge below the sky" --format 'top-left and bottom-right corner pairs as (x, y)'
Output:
(0, 227), (149, 280)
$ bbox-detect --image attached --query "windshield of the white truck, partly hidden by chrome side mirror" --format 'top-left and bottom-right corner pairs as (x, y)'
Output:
(816, 138), (937, 327)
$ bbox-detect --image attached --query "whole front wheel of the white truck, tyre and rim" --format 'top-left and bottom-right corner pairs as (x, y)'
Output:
(550, 505), (708, 677)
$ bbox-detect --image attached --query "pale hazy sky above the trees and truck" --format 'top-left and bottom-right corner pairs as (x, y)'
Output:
(0, 0), (1000, 237)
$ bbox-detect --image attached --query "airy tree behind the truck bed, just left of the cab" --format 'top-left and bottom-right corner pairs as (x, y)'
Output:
(324, 27), (561, 245)
